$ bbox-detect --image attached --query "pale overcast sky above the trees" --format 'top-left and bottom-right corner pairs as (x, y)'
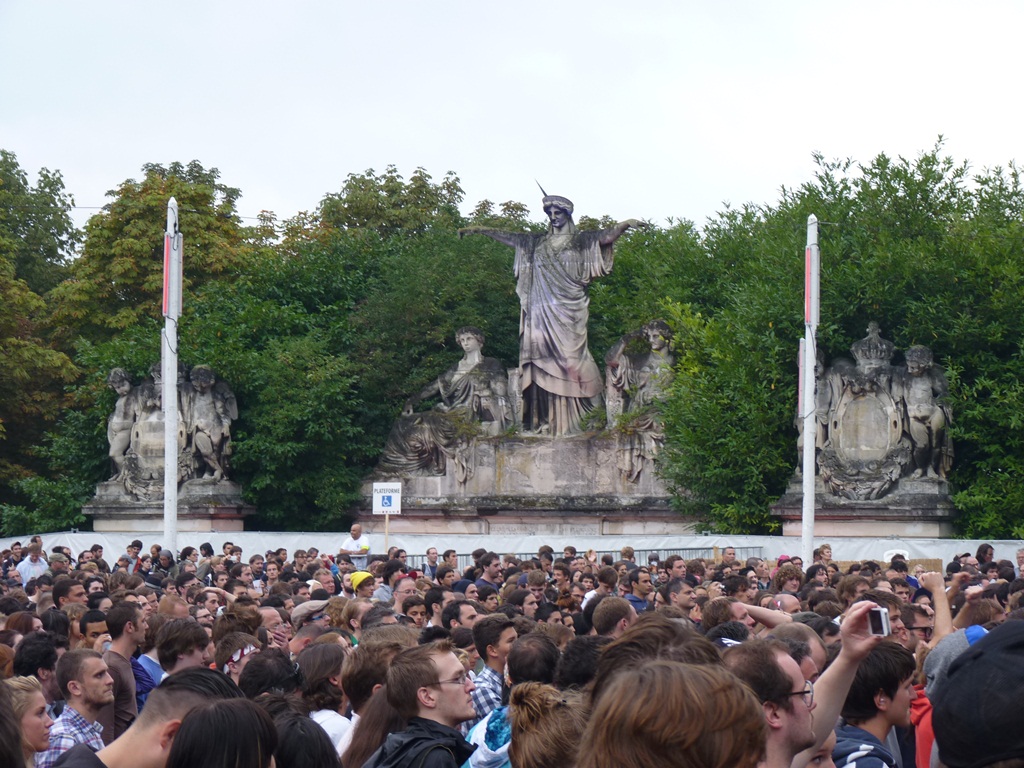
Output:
(0, 0), (1024, 234)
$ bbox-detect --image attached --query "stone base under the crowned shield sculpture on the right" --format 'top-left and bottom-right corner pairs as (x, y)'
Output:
(772, 476), (956, 539)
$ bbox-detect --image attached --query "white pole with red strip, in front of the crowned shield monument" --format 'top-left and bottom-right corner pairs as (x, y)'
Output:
(800, 214), (821, 566)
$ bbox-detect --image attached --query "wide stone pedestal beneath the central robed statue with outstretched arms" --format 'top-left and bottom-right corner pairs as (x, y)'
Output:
(360, 434), (696, 537)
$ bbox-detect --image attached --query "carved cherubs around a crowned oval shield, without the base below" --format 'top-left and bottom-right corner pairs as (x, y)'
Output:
(815, 323), (952, 500)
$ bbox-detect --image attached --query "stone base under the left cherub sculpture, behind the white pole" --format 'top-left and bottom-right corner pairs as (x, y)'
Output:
(82, 478), (256, 534)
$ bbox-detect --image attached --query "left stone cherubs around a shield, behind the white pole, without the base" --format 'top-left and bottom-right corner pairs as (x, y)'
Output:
(106, 364), (239, 501)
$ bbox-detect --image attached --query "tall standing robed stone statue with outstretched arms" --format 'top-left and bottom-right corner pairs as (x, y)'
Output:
(459, 195), (642, 436)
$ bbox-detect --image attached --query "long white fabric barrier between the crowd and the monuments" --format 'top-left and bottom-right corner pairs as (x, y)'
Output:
(0, 532), (1024, 566)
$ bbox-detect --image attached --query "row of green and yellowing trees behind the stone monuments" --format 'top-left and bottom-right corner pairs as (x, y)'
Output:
(6, 144), (1024, 537)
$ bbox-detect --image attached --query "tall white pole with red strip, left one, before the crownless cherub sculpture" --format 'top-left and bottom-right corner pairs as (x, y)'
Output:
(160, 198), (182, 558)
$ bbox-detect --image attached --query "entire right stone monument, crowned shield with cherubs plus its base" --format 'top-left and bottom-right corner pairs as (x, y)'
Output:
(772, 323), (955, 537)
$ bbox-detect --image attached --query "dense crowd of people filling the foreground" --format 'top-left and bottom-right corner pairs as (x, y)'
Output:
(0, 525), (1024, 768)
